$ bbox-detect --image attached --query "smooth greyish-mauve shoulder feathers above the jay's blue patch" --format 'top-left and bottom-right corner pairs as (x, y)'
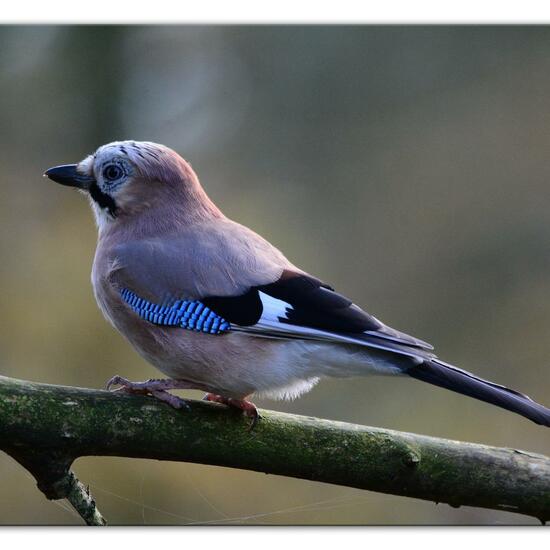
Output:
(109, 220), (299, 302)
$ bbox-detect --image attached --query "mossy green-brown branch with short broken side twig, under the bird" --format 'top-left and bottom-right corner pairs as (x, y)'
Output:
(0, 376), (550, 525)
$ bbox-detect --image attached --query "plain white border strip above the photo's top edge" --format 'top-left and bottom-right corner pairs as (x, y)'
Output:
(0, 0), (550, 24)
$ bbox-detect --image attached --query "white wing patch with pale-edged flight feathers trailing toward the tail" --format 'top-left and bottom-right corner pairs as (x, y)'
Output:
(231, 292), (432, 359)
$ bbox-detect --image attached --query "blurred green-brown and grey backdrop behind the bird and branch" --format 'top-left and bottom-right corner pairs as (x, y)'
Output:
(0, 26), (550, 524)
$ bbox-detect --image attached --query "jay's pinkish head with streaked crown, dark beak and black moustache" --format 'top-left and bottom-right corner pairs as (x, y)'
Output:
(44, 141), (219, 228)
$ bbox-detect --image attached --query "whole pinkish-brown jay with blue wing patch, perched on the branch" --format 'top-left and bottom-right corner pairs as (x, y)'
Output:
(44, 140), (550, 426)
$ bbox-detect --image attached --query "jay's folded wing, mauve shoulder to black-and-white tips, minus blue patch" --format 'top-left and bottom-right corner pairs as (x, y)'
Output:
(110, 224), (433, 356)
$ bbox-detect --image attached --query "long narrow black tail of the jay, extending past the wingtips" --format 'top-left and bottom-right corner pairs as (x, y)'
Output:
(406, 359), (550, 426)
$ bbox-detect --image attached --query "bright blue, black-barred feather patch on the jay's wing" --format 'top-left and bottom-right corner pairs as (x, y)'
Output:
(120, 288), (231, 334)
